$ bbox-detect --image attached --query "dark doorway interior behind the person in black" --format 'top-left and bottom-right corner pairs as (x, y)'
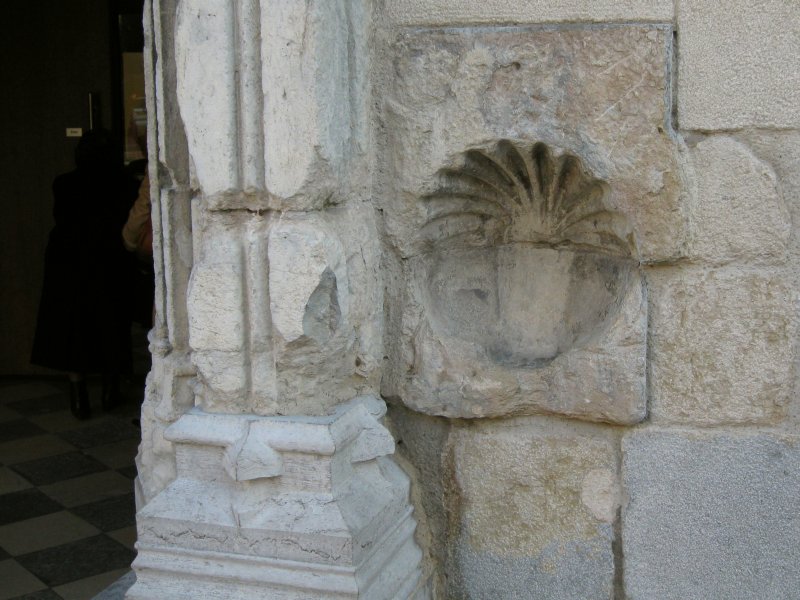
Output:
(0, 0), (143, 376)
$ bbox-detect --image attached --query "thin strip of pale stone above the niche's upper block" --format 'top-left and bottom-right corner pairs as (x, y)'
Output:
(379, 0), (673, 25)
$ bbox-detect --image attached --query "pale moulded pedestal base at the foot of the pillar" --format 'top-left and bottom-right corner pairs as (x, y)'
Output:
(126, 397), (427, 600)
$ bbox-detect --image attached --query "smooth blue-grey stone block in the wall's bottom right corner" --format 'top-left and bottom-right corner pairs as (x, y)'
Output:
(622, 430), (800, 600)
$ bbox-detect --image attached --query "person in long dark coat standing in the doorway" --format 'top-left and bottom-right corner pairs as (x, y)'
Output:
(31, 130), (137, 419)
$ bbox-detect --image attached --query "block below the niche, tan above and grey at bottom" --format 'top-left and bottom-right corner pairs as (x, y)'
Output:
(448, 419), (619, 599)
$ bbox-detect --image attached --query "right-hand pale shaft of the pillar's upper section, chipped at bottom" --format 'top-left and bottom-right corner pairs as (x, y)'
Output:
(261, 0), (359, 207)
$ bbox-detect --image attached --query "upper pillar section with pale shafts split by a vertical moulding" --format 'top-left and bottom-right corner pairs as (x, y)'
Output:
(175, 0), (369, 210)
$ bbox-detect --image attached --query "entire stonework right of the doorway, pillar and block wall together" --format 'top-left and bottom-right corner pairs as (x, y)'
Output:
(136, 0), (800, 600)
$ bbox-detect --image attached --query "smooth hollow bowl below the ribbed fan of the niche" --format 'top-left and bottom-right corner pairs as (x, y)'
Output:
(426, 243), (634, 367)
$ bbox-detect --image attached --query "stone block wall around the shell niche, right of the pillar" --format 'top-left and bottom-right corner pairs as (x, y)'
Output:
(377, 0), (800, 600)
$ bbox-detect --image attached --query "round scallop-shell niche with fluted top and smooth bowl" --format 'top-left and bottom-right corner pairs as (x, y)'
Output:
(422, 140), (633, 366)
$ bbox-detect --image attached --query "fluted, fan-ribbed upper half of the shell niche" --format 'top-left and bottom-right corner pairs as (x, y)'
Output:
(421, 140), (634, 256)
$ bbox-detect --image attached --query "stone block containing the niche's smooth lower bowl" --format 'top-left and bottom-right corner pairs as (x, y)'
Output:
(382, 243), (647, 423)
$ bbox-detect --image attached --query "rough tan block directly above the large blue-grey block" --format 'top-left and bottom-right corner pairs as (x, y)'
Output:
(648, 268), (797, 425)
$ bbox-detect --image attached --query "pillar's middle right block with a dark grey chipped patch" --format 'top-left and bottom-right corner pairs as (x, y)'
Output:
(262, 202), (384, 415)
